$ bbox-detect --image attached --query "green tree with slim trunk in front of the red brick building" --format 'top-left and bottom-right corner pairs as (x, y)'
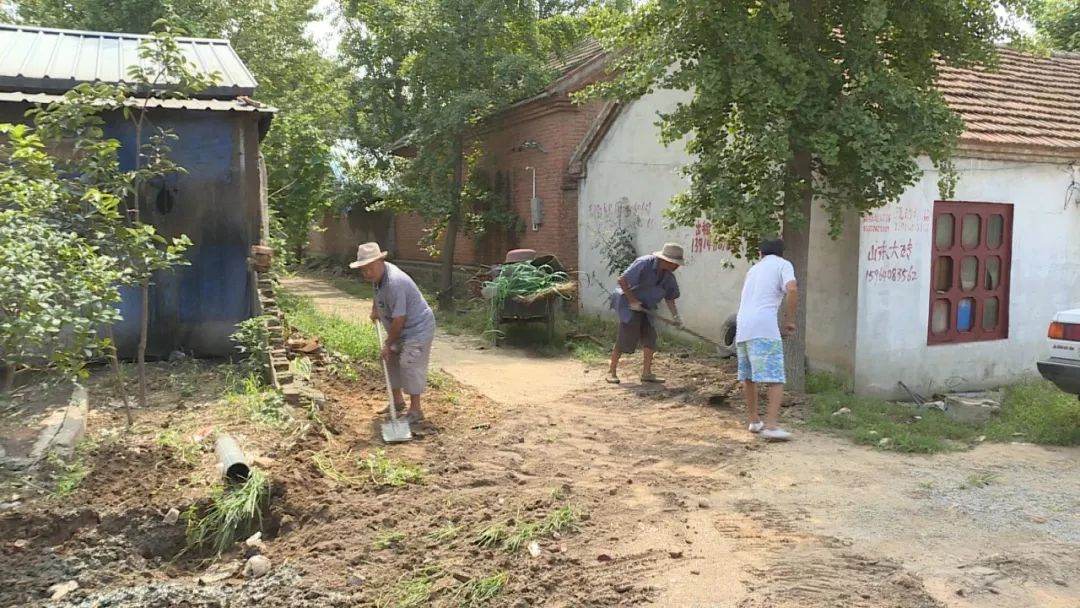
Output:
(343, 0), (546, 307)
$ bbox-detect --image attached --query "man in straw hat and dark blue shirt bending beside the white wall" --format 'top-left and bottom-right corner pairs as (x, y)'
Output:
(607, 243), (686, 384)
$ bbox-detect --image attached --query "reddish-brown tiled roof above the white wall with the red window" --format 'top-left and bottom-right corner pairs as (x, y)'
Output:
(937, 49), (1080, 157)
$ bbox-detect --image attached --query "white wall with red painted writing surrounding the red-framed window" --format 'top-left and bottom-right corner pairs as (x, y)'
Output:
(855, 155), (1080, 396)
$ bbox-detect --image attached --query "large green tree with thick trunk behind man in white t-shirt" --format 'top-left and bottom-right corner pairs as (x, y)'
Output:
(598, 0), (1022, 389)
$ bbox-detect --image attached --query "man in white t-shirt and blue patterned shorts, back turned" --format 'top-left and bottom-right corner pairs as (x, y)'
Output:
(735, 240), (798, 441)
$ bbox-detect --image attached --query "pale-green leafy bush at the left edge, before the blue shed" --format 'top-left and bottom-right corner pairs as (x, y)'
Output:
(0, 124), (124, 392)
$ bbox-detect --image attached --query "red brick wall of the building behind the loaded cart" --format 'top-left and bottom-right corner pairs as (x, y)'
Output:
(395, 95), (603, 268)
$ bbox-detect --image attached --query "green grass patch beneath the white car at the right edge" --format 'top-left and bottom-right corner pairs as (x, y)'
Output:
(986, 380), (1080, 445)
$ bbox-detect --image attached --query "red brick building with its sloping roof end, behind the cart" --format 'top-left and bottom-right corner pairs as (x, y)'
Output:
(391, 41), (616, 268)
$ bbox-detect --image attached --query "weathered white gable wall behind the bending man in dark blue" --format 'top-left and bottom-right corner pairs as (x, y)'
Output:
(578, 91), (746, 340)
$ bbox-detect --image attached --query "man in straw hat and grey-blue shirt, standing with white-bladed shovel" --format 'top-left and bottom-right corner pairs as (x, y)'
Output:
(349, 243), (435, 422)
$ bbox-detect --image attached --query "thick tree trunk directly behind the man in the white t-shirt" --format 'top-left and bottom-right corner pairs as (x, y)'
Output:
(783, 150), (813, 392)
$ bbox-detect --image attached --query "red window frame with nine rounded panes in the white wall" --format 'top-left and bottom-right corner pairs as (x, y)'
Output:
(927, 201), (1013, 344)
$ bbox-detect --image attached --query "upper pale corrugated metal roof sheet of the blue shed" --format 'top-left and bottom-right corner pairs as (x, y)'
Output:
(0, 24), (257, 97)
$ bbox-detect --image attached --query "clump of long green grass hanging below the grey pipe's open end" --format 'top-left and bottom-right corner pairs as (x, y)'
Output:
(185, 469), (270, 555)
